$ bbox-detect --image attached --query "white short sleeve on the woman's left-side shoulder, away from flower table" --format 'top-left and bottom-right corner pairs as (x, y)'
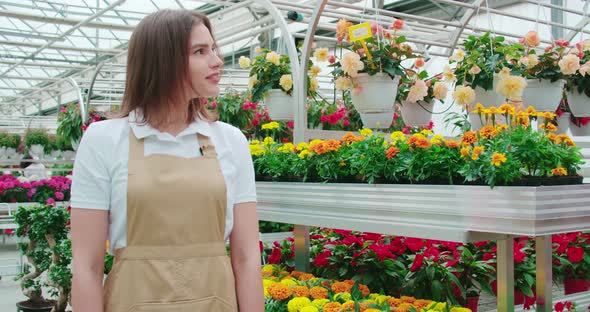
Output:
(70, 123), (111, 210)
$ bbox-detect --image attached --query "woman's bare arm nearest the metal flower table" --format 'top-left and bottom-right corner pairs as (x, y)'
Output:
(230, 202), (264, 312)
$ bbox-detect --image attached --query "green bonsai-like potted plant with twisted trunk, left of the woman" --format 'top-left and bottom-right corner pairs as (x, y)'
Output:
(15, 205), (71, 312)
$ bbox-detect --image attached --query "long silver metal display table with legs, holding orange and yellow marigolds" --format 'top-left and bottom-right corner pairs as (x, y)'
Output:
(256, 182), (590, 311)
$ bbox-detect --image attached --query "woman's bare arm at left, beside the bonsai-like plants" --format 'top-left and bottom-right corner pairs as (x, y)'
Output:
(71, 208), (109, 312)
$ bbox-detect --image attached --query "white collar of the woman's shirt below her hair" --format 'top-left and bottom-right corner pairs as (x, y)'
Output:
(129, 111), (211, 140)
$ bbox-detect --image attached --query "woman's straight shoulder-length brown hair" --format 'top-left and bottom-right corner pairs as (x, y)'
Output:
(118, 10), (216, 127)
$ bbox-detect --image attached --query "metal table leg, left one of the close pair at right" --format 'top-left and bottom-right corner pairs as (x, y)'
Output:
(496, 236), (514, 312)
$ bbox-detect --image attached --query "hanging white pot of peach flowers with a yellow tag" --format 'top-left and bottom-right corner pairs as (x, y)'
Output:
(329, 19), (416, 128)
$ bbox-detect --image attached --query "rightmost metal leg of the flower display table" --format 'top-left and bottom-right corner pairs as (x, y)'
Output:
(535, 235), (553, 312)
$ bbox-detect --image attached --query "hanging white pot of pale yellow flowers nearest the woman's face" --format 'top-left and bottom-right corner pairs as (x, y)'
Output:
(239, 48), (320, 120)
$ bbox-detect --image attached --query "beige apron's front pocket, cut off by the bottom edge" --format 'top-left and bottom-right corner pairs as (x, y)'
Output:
(128, 296), (238, 312)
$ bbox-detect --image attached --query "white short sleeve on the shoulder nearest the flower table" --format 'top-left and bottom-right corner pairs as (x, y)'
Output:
(233, 128), (256, 204)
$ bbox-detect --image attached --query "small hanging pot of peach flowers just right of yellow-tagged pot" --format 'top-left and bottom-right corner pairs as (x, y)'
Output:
(397, 58), (449, 127)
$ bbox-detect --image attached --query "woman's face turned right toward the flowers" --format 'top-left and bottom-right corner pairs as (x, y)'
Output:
(188, 23), (223, 99)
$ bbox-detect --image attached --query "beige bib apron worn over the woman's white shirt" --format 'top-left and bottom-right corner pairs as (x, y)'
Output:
(105, 131), (237, 312)
